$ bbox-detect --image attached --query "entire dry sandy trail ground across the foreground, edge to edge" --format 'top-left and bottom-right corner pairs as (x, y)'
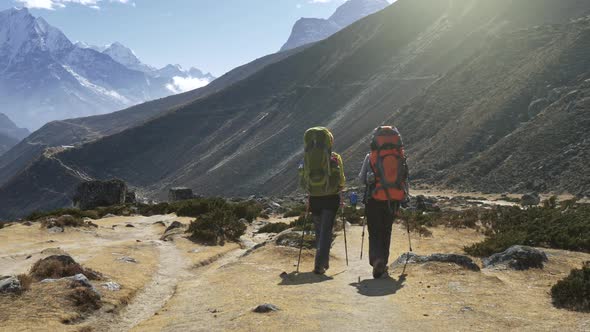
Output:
(0, 211), (590, 331)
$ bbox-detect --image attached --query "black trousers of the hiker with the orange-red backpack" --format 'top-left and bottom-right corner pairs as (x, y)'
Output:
(365, 199), (399, 266)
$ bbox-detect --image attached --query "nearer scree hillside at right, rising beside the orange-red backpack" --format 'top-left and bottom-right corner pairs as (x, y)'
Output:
(374, 19), (590, 196)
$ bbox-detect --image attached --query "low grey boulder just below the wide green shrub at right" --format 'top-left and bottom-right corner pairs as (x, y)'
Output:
(483, 246), (549, 270)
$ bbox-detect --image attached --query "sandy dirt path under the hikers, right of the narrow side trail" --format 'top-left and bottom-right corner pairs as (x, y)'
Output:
(126, 223), (590, 331)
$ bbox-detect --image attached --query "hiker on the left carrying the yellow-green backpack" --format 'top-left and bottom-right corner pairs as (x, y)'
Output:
(299, 127), (345, 274)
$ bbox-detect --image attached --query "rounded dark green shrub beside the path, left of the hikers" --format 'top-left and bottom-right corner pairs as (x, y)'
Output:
(187, 209), (246, 245)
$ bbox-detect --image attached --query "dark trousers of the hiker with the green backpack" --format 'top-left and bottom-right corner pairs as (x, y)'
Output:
(309, 195), (340, 269)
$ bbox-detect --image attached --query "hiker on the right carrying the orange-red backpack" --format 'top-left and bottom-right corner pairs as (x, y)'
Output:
(359, 126), (408, 279)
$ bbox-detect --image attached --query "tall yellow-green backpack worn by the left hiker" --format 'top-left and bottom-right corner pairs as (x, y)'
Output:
(301, 127), (340, 196)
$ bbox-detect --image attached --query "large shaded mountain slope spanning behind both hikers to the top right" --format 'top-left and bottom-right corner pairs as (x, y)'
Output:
(0, 0), (590, 216)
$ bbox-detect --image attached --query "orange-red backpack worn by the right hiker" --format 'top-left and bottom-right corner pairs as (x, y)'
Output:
(370, 126), (408, 201)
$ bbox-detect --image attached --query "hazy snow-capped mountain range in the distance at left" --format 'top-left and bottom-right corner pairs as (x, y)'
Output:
(0, 8), (215, 129)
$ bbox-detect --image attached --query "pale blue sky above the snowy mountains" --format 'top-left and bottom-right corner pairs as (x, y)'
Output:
(0, 0), (356, 75)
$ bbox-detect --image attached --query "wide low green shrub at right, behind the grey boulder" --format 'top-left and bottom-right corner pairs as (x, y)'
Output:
(465, 200), (590, 256)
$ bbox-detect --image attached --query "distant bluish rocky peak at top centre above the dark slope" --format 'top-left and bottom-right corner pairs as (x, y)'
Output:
(281, 0), (389, 51)
